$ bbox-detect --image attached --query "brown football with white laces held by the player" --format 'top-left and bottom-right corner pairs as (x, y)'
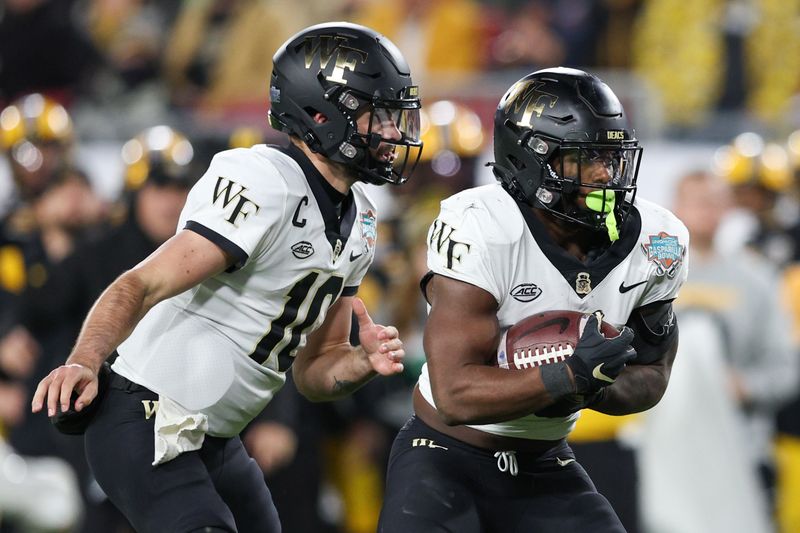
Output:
(496, 311), (619, 370)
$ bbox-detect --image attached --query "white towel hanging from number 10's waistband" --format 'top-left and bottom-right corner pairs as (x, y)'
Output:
(153, 396), (208, 466)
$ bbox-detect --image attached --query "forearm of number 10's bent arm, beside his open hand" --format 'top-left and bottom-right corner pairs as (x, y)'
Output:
(294, 343), (377, 402)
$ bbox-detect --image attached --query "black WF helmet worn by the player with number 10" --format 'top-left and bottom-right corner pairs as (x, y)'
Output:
(269, 22), (422, 184)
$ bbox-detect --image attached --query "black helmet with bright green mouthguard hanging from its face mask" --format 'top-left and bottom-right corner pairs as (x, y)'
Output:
(492, 68), (642, 241)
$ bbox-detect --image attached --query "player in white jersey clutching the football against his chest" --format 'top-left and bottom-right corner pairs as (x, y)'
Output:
(379, 68), (689, 533)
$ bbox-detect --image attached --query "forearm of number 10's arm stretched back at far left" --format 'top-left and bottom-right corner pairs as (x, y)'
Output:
(67, 271), (155, 372)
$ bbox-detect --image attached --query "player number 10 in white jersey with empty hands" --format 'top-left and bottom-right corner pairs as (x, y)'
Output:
(32, 23), (422, 533)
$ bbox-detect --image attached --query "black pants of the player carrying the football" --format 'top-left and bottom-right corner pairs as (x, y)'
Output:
(378, 417), (625, 533)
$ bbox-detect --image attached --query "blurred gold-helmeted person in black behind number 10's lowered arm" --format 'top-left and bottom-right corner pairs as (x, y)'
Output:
(21, 125), (202, 338)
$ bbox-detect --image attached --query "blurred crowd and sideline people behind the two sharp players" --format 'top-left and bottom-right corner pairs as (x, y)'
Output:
(0, 0), (800, 533)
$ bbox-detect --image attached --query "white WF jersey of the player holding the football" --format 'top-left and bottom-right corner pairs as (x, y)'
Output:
(419, 184), (689, 440)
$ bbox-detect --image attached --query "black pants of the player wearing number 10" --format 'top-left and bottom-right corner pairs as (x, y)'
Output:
(84, 374), (281, 533)
